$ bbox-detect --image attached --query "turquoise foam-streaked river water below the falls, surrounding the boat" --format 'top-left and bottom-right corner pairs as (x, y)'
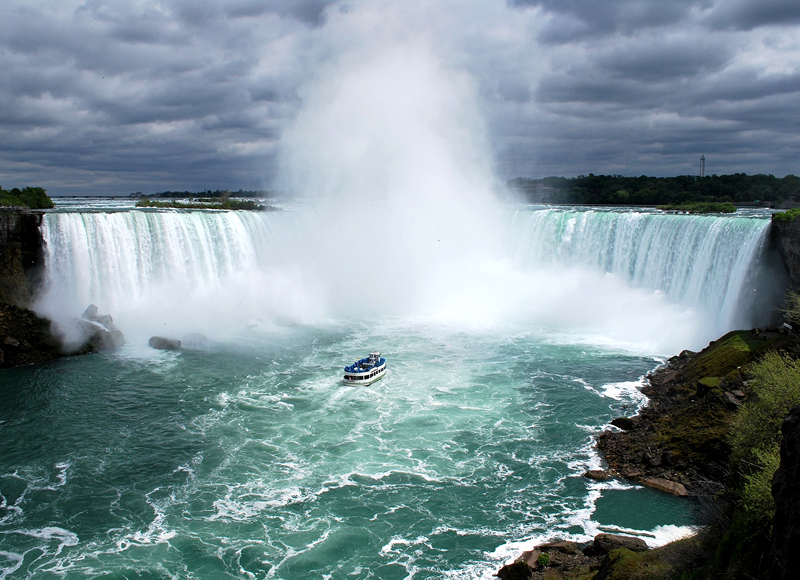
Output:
(0, 319), (691, 579)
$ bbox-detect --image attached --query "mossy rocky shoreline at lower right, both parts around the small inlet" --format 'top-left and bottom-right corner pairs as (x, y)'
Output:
(497, 328), (797, 580)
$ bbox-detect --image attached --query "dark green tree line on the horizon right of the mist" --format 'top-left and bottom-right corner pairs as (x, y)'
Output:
(507, 173), (800, 205)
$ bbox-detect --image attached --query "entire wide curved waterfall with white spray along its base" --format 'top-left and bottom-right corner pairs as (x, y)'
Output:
(37, 208), (780, 353)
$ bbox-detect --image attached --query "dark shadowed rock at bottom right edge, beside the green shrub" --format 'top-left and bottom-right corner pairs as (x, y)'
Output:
(771, 406), (800, 580)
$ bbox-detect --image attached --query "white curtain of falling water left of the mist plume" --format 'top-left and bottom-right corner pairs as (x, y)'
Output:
(35, 210), (313, 342)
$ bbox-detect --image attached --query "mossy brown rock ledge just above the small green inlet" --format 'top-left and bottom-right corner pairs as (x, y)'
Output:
(597, 329), (794, 495)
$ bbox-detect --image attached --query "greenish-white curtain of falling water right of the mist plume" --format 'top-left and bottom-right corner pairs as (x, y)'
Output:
(511, 209), (769, 332)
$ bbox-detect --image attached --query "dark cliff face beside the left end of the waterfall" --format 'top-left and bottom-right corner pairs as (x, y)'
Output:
(0, 208), (44, 308)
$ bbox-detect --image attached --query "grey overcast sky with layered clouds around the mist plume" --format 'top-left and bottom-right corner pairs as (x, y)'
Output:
(0, 0), (800, 195)
